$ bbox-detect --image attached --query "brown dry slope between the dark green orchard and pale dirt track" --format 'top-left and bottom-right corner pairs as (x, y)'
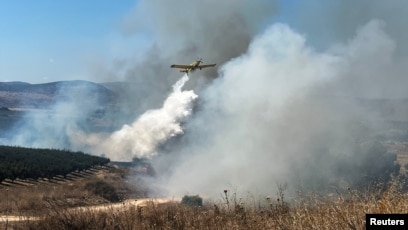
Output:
(0, 165), (134, 214)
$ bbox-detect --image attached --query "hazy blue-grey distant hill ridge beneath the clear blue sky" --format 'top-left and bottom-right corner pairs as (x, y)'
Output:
(0, 81), (116, 109)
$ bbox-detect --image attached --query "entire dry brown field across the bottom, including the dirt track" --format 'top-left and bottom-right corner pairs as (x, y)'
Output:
(0, 152), (408, 229)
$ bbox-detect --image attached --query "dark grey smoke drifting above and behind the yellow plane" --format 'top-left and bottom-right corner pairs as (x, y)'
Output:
(95, 0), (277, 116)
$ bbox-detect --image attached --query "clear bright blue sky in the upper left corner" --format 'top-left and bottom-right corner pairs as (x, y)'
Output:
(0, 0), (143, 83)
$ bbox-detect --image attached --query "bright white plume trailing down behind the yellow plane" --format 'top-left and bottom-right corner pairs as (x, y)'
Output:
(70, 75), (197, 161)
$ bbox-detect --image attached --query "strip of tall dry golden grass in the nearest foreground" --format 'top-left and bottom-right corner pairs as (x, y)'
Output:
(6, 182), (408, 229)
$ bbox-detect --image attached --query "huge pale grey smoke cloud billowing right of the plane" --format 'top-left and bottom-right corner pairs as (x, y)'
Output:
(154, 20), (408, 195)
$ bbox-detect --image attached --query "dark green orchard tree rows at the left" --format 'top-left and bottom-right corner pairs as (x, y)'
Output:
(0, 146), (109, 182)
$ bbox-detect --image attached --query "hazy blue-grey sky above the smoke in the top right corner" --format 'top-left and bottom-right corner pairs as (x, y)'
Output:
(291, 0), (408, 56)
